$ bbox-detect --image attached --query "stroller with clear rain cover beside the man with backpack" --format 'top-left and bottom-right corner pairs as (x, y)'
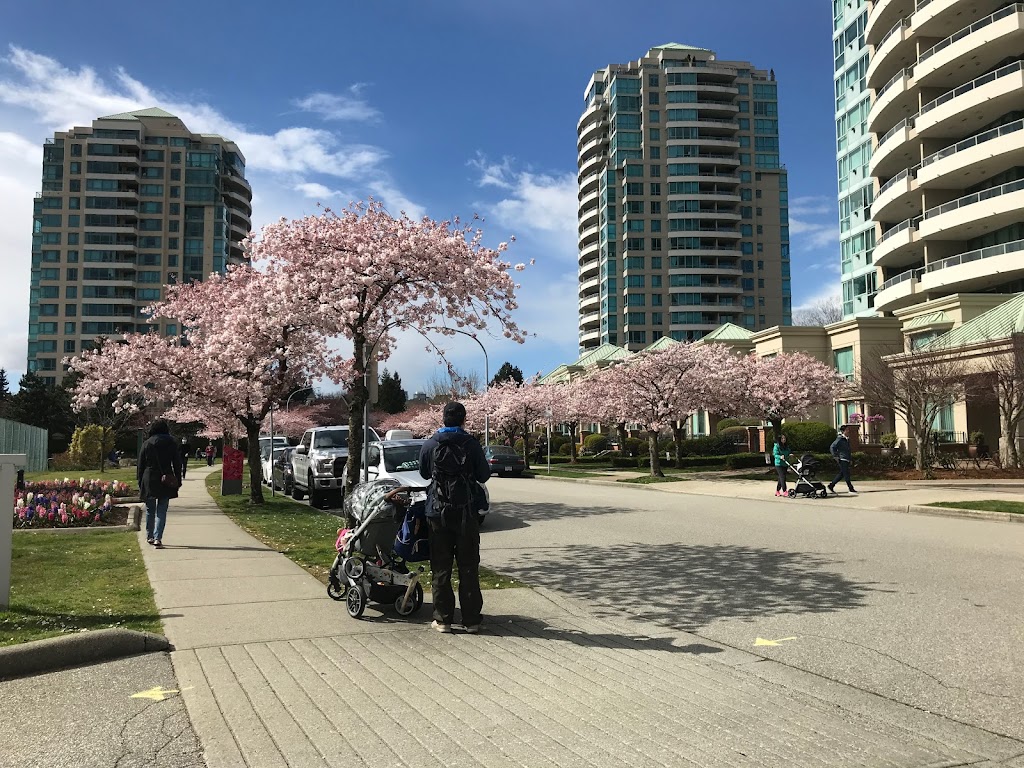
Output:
(327, 478), (425, 618)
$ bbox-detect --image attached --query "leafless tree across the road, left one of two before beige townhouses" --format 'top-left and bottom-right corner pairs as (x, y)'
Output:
(860, 350), (968, 477)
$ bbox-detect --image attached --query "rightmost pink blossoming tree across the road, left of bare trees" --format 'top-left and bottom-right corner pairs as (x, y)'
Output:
(737, 352), (849, 442)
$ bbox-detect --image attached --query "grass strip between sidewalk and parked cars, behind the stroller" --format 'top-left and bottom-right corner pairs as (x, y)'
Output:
(206, 471), (523, 589)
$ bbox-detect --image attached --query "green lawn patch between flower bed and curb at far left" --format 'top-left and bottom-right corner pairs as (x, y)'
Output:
(0, 531), (163, 645)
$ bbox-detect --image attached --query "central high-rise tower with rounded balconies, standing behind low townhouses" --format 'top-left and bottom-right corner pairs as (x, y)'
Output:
(577, 43), (792, 350)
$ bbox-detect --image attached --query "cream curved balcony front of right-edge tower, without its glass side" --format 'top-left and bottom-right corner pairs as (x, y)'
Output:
(864, 0), (1024, 313)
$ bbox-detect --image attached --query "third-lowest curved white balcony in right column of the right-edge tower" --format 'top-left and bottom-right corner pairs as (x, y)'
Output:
(920, 120), (1024, 187)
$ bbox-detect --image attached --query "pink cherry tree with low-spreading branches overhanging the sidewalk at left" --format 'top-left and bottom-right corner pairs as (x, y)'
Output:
(69, 266), (321, 503)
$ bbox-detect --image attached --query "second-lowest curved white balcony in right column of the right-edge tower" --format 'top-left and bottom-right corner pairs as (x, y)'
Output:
(917, 179), (1024, 240)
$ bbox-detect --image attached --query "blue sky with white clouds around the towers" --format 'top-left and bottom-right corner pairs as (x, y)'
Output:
(0, 0), (839, 392)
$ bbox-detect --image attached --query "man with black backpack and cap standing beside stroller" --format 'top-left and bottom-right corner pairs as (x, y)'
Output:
(420, 401), (490, 635)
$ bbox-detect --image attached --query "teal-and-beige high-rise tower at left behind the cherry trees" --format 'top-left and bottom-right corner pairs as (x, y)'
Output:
(28, 109), (252, 383)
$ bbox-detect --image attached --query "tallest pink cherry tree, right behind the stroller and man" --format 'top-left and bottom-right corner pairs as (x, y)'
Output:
(251, 200), (525, 492)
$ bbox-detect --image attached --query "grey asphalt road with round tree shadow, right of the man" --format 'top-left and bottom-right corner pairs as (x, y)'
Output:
(482, 478), (1024, 738)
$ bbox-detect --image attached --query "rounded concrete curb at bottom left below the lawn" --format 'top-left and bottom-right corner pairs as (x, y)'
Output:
(0, 628), (172, 680)
